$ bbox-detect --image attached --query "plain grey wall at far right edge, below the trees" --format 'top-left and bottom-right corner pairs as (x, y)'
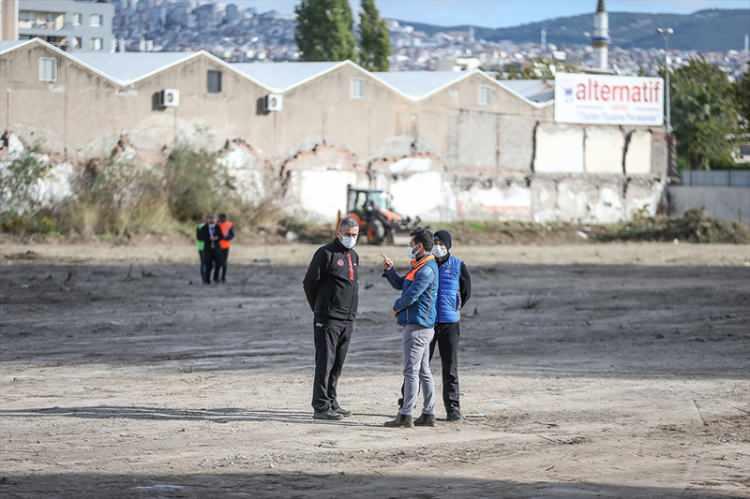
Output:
(668, 186), (750, 224)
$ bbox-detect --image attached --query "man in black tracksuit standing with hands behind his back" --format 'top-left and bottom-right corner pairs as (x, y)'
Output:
(304, 218), (359, 420)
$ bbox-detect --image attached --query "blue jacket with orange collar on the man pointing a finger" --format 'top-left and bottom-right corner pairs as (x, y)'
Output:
(383, 255), (440, 329)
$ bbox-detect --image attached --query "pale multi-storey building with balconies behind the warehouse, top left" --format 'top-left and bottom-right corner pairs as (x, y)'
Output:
(18, 0), (115, 52)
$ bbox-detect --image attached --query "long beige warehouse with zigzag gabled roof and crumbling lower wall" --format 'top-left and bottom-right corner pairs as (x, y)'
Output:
(0, 40), (667, 222)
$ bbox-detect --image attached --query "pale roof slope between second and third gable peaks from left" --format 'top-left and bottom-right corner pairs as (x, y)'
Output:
(231, 62), (342, 92)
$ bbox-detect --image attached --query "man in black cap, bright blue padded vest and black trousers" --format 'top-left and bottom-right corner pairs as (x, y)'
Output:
(430, 230), (471, 422)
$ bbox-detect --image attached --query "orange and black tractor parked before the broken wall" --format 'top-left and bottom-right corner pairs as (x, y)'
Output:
(337, 185), (422, 244)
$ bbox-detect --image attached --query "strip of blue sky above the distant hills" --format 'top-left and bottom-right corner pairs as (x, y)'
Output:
(238, 0), (750, 27)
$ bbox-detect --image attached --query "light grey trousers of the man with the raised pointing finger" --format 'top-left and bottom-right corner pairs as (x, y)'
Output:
(400, 326), (435, 416)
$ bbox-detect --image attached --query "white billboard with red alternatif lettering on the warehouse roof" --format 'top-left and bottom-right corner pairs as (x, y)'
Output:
(555, 73), (664, 126)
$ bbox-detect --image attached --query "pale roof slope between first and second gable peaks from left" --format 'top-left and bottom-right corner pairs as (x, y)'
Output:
(69, 52), (196, 85)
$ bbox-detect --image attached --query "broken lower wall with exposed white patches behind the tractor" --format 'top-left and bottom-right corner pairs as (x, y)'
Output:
(0, 119), (666, 223)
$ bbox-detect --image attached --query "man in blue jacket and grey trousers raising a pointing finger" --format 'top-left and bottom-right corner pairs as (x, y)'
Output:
(383, 230), (439, 428)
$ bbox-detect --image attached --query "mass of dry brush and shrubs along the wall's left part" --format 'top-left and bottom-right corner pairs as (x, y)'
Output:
(0, 146), (281, 239)
